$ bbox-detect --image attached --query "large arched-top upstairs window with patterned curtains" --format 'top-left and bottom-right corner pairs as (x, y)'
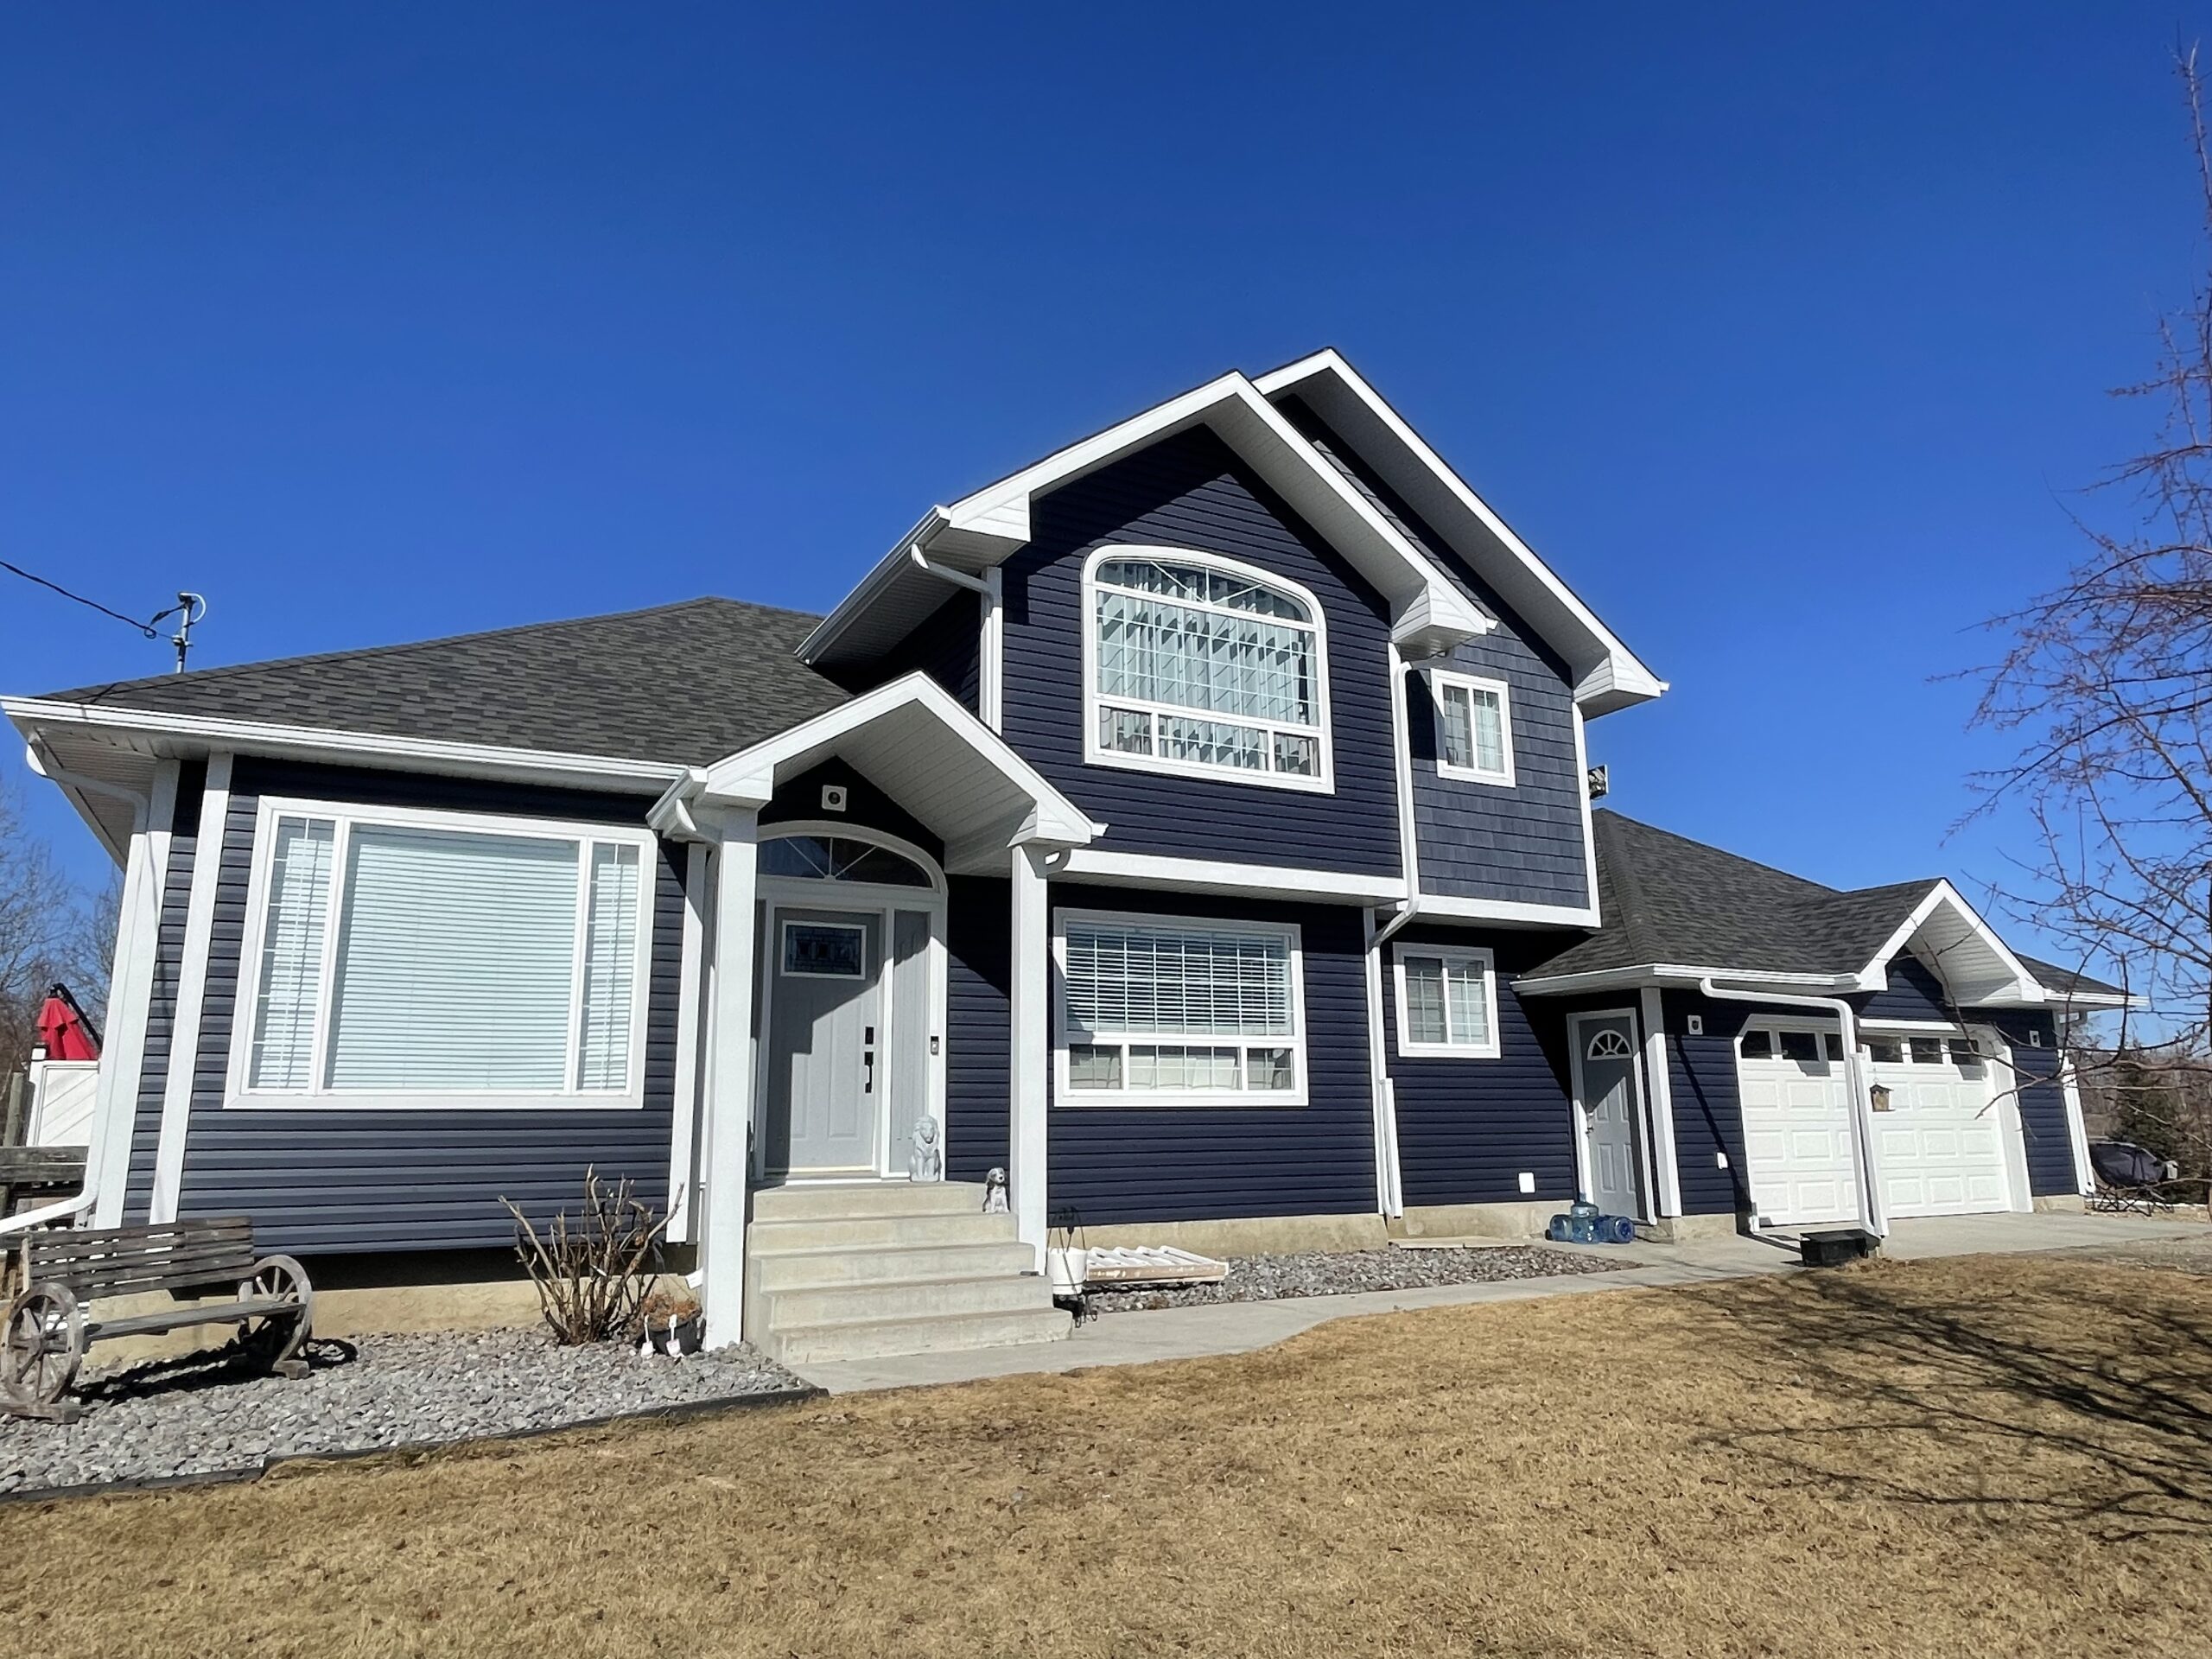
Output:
(1084, 546), (1330, 790)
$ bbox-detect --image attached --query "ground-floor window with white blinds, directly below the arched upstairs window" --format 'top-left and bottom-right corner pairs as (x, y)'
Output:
(1053, 912), (1305, 1106)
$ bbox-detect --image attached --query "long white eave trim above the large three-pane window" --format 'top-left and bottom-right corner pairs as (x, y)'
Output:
(0, 696), (683, 794)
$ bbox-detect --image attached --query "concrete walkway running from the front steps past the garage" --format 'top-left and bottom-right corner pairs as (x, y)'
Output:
(791, 1214), (2205, 1394)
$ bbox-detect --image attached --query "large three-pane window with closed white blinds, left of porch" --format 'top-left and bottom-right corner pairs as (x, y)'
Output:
(232, 801), (655, 1109)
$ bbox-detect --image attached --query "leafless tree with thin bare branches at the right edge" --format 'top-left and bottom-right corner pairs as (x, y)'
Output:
(1975, 47), (2212, 1173)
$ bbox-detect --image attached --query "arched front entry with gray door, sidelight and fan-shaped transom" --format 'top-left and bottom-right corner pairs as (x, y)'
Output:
(754, 823), (944, 1181)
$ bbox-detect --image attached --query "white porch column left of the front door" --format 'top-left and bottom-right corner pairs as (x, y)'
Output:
(696, 805), (759, 1347)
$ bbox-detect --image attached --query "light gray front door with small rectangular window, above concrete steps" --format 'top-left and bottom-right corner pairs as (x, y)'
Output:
(763, 907), (882, 1174)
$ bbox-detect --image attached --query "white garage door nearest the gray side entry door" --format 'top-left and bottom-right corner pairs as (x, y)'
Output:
(1737, 1024), (1858, 1228)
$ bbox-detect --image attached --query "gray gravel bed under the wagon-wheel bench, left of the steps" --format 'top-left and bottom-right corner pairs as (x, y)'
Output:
(0, 1330), (805, 1493)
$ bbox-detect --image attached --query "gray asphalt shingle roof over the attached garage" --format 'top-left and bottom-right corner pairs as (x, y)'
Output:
(1526, 810), (2113, 991)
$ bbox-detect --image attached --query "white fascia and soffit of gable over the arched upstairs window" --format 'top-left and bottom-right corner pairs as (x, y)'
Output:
(798, 372), (1497, 664)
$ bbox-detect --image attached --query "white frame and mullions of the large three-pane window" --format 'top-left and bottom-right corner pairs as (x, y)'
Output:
(224, 797), (659, 1113)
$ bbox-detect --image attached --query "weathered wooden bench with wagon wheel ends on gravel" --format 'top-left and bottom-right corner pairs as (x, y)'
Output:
(0, 1217), (315, 1422)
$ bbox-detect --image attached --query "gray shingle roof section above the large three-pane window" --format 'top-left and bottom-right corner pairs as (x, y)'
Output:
(36, 600), (845, 766)
